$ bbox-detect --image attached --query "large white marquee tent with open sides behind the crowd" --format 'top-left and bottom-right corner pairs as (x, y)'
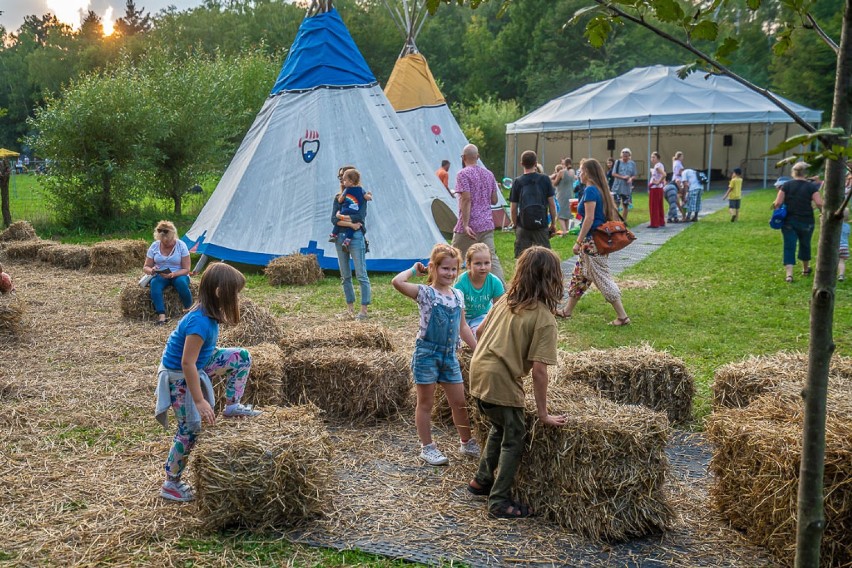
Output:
(506, 65), (822, 183)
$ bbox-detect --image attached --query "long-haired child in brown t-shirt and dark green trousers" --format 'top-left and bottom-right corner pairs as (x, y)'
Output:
(468, 246), (565, 519)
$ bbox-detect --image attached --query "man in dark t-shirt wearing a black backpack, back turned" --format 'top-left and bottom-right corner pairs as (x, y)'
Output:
(509, 150), (556, 258)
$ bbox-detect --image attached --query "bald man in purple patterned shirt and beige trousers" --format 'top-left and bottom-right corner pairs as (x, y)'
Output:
(453, 144), (506, 282)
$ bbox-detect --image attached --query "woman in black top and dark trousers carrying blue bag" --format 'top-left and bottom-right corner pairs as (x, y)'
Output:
(772, 162), (822, 282)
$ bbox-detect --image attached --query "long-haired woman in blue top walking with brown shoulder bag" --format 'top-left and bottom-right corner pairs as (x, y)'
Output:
(556, 158), (630, 326)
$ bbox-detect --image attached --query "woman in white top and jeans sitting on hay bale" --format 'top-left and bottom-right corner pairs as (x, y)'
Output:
(142, 221), (192, 325)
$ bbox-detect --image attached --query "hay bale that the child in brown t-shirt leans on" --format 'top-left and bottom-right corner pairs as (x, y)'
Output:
(472, 378), (674, 541)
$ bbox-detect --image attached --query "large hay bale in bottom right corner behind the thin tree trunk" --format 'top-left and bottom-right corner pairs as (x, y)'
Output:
(707, 391), (852, 566)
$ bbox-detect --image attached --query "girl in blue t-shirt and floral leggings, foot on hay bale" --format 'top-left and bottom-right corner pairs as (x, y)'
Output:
(155, 263), (260, 501)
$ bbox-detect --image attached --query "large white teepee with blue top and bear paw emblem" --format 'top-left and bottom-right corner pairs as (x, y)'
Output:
(183, 10), (456, 271)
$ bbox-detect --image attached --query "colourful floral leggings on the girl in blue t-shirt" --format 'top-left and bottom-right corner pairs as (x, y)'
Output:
(166, 347), (251, 481)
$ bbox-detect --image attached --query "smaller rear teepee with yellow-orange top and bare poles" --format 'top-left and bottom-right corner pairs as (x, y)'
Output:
(385, 0), (506, 207)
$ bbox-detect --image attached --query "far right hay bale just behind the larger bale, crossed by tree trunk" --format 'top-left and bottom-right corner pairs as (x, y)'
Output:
(713, 351), (852, 410)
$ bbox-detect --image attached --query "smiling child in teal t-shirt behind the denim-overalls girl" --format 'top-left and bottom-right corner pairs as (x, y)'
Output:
(455, 243), (506, 335)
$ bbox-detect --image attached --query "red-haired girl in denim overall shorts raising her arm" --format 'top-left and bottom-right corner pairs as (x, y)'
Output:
(391, 244), (479, 465)
